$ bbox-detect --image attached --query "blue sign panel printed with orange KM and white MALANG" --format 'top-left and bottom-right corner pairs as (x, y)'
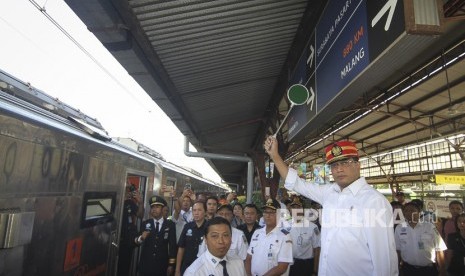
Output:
(316, 0), (370, 110)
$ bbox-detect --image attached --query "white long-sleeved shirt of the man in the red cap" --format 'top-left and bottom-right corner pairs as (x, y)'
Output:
(284, 168), (399, 276)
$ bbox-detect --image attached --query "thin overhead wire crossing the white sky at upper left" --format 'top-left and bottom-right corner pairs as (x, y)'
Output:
(29, 0), (151, 112)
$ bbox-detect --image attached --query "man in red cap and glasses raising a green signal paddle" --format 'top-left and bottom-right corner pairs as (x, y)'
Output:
(264, 137), (398, 276)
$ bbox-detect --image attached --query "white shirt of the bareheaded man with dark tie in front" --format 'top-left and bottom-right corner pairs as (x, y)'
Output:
(184, 250), (246, 276)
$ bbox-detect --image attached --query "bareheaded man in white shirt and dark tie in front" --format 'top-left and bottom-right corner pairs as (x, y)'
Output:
(184, 217), (245, 276)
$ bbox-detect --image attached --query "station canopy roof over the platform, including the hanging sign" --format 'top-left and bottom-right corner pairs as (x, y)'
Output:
(65, 0), (465, 183)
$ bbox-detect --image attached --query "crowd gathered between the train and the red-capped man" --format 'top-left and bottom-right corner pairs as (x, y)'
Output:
(118, 182), (320, 276)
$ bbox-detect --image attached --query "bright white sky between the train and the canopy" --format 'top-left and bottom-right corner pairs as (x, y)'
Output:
(0, 0), (221, 182)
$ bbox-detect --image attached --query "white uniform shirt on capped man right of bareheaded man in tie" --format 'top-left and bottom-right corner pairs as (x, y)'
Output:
(247, 227), (294, 276)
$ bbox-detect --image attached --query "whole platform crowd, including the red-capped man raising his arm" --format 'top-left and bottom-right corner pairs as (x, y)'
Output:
(119, 137), (465, 276)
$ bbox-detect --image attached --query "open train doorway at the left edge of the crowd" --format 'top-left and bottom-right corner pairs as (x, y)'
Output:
(117, 174), (147, 276)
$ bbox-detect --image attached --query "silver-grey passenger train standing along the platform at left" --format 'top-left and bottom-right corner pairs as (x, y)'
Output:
(0, 67), (227, 276)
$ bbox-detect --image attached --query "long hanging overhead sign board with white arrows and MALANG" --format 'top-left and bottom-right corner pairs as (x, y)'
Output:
(288, 0), (405, 139)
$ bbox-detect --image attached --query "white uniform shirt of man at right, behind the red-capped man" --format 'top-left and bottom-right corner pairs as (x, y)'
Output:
(395, 222), (447, 266)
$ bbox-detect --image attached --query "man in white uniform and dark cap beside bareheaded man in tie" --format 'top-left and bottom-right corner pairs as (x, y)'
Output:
(245, 198), (293, 276)
